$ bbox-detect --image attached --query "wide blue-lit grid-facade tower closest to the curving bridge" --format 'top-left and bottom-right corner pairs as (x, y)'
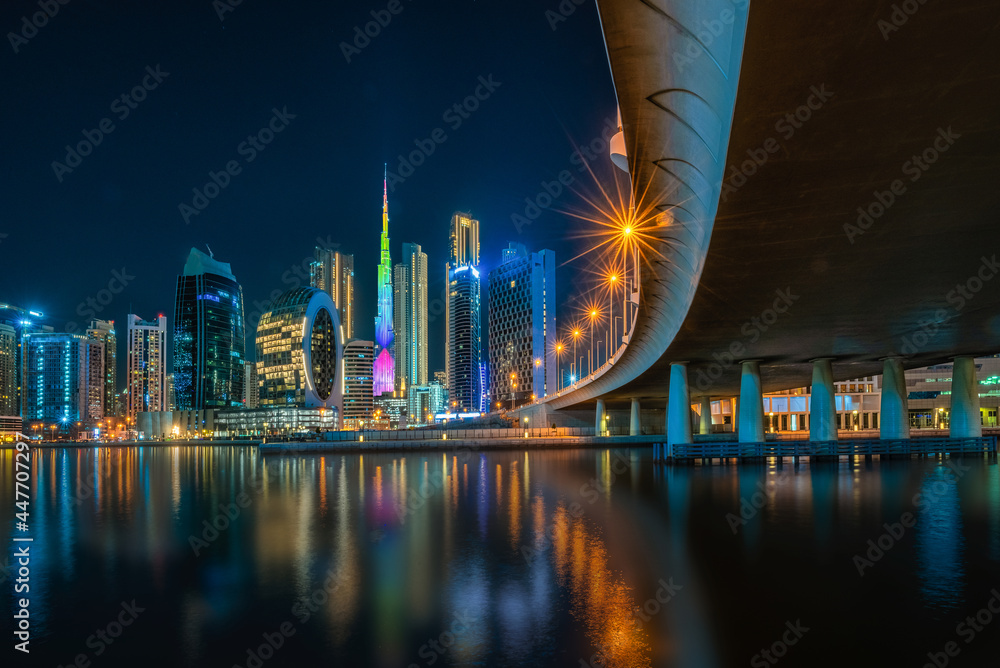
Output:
(487, 243), (558, 407)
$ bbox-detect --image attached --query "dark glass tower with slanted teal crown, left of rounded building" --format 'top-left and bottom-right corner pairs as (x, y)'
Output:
(174, 248), (246, 410)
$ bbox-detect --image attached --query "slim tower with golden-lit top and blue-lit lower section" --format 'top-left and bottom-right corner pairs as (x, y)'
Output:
(445, 213), (483, 413)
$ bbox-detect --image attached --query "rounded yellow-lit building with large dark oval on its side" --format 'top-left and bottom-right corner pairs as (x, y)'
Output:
(256, 287), (342, 408)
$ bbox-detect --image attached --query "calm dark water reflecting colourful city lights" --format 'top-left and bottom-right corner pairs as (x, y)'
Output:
(0, 447), (1000, 668)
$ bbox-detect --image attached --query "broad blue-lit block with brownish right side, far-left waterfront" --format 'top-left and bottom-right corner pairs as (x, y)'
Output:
(23, 332), (104, 426)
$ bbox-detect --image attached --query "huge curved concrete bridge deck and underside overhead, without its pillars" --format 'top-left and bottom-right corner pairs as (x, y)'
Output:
(548, 0), (1000, 409)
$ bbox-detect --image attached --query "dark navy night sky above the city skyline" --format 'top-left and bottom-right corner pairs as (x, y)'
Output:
(0, 0), (616, 371)
